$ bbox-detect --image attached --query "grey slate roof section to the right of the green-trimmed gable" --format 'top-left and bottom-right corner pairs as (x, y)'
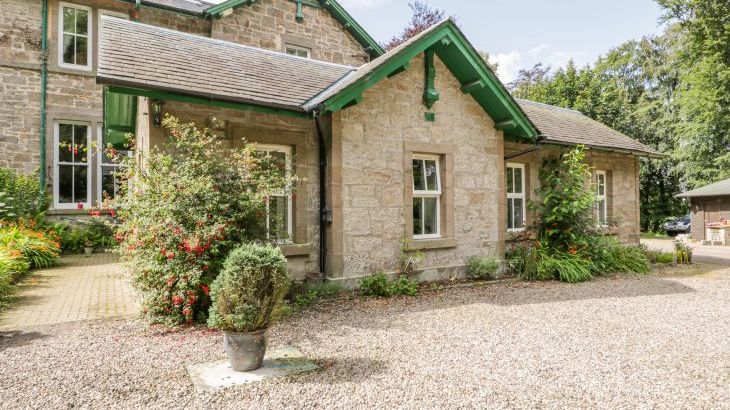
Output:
(515, 98), (662, 157)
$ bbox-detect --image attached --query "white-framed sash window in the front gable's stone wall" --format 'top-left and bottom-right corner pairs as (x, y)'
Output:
(413, 155), (441, 239)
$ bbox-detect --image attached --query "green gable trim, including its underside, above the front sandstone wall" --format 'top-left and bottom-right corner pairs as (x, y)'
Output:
(319, 20), (538, 141)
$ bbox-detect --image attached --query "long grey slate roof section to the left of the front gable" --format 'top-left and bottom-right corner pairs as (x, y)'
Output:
(97, 16), (354, 111)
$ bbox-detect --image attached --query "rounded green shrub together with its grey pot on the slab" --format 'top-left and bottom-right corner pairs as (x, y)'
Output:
(208, 244), (289, 372)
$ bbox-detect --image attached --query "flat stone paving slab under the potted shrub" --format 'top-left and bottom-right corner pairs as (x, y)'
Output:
(187, 347), (319, 391)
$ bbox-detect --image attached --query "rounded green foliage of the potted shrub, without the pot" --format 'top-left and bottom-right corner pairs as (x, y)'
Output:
(206, 244), (289, 332)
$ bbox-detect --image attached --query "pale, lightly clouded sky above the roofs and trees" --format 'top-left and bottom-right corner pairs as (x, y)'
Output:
(340, 0), (661, 82)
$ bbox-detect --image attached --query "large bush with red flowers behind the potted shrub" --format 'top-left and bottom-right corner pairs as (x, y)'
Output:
(112, 116), (294, 325)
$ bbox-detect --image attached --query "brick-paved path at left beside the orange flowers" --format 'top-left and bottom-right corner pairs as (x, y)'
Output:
(0, 254), (137, 330)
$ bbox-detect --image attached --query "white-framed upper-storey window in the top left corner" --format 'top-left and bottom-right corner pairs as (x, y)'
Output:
(58, 3), (92, 70)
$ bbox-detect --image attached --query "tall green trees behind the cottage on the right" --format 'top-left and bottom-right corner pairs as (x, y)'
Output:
(510, 0), (730, 230)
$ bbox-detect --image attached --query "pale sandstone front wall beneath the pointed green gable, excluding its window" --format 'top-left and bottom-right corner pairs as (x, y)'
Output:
(328, 52), (504, 278)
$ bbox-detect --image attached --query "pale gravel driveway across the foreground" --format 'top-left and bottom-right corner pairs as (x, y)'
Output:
(0, 269), (730, 409)
